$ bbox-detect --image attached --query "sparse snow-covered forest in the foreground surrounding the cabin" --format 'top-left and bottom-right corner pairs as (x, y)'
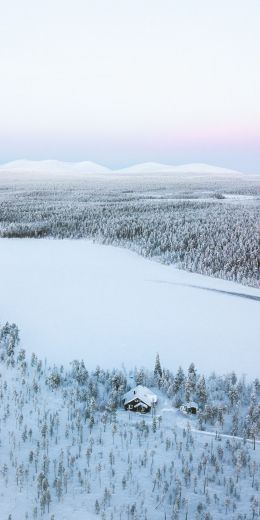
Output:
(0, 323), (260, 520)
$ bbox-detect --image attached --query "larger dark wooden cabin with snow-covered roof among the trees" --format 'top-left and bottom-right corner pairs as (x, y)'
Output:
(123, 385), (157, 413)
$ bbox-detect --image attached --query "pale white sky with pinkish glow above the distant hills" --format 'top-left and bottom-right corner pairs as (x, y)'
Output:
(0, 0), (260, 173)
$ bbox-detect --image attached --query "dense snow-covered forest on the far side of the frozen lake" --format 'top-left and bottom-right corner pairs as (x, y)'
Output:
(0, 175), (260, 287)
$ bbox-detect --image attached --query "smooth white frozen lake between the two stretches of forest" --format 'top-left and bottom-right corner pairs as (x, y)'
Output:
(0, 239), (260, 377)
